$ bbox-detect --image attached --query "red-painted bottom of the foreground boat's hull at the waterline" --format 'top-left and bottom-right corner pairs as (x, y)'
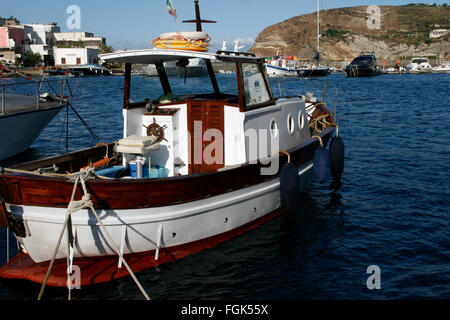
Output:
(0, 209), (281, 287)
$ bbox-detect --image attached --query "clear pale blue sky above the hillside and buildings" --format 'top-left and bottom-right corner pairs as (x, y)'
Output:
(0, 0), (449, 51)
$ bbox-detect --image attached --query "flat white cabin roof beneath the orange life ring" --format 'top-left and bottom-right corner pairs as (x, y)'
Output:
(99, 48), (261, 64)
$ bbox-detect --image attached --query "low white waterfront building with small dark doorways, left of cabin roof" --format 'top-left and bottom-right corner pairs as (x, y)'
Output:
(53, 47), (99, 67)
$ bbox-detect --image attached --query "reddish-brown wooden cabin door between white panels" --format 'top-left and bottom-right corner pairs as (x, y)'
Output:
(187, 100), (225, 174)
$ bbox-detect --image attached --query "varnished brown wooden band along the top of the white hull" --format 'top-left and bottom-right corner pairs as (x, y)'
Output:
(0, 127), (334, 209)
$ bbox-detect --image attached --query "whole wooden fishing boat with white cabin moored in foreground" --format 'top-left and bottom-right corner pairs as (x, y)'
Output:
(0, 1), (342, 286)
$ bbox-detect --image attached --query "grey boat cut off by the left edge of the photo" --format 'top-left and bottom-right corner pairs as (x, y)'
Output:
(0, 83), (65, 160)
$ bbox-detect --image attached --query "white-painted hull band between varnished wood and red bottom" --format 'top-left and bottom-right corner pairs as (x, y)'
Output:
(10, 162), (313, 262)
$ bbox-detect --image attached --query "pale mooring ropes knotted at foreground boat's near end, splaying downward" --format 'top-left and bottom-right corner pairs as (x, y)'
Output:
(37, 168), (150, 300)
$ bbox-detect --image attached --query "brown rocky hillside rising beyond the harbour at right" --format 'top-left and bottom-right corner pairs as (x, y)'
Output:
(249, 4), (450, 62)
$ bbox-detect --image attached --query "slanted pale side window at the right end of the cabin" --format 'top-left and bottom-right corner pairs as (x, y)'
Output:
(242, 63), (270, 107)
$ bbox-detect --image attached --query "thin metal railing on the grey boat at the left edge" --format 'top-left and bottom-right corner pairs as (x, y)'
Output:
(0, 78), (72, 115)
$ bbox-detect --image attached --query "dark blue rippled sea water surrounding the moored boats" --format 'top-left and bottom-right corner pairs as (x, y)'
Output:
(0, 74), (450, 301)
